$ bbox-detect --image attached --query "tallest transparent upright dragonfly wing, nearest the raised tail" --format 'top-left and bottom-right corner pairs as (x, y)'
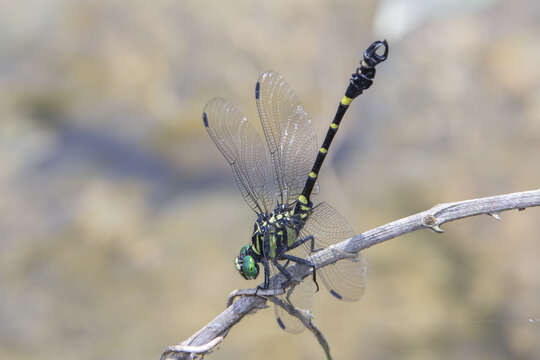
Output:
(255, 71), (317, 203)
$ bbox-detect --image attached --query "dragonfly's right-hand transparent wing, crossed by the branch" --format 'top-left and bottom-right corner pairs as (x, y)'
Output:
(300, 202), (367, 301)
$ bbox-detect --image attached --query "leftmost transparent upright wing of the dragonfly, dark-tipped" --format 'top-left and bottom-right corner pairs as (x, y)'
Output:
(203, 98), (276, 213)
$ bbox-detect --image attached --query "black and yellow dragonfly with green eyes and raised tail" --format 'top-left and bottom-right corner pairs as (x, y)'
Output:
(202, 40), (388, 332)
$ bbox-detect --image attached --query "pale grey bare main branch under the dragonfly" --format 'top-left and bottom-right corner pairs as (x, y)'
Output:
(162, 189), (540, 360)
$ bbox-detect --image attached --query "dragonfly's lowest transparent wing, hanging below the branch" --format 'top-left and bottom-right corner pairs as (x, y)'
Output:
(270, 264), (316, 334)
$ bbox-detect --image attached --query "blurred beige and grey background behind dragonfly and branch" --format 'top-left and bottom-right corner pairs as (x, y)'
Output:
(0, 0), (540, 360)
